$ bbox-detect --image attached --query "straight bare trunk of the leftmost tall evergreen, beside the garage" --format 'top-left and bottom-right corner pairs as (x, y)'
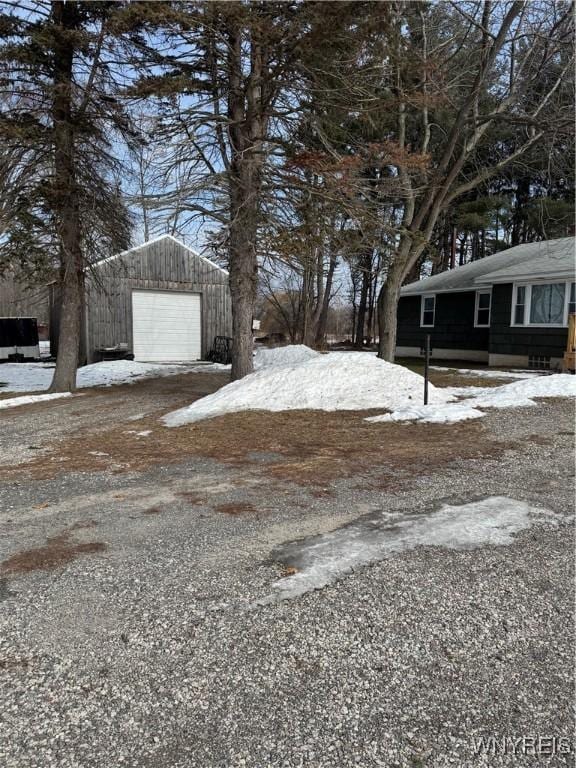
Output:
(50, 2), (84, 392)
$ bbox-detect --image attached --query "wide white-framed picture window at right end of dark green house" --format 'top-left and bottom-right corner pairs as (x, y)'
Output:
(512, 283), (576, 327)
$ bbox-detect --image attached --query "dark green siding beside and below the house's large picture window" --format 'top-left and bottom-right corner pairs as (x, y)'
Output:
(488, 283), (568, 358)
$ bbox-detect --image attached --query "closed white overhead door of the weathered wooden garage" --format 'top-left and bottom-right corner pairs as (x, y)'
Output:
(132, 291), (202, 363)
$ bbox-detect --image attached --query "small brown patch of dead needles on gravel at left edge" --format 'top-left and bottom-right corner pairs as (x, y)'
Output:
(0, 523), (106, 573)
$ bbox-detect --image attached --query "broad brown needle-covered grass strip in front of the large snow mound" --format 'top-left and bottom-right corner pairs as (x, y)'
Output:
(0, 404), (510, 488)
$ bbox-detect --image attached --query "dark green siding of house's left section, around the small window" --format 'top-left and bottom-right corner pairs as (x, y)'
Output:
(397, 291), (489, 355)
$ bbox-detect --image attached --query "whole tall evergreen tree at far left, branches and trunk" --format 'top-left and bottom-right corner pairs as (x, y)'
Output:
(0, 0), (130, 391)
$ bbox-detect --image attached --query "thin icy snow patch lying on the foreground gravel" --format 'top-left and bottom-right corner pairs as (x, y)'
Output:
(258, 496), (561, 605)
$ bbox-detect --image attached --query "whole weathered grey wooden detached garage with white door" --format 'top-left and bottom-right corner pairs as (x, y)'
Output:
(50, 235), (231, 363)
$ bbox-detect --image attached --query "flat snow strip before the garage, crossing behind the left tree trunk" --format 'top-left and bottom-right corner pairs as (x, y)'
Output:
(0, 360), (207, 392)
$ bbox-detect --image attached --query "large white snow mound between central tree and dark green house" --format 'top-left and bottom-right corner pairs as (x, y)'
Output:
(164, 352), (453, 427)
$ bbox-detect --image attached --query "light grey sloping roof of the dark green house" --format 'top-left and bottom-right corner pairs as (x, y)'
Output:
(401, 237), (575, 296)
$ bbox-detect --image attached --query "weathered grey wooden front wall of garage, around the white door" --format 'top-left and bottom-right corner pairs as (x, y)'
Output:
(86, 238), (232, 362)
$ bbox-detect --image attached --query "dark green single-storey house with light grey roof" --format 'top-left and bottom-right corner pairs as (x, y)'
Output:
(396, 237), (576, 368)
